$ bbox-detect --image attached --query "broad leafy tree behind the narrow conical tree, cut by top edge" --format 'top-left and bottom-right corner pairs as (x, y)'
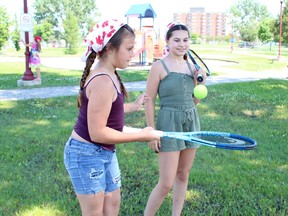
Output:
(34, 0), (97, 39)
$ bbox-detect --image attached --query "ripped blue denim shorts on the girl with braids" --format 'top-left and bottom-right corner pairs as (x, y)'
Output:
(64, 137), (121, 194)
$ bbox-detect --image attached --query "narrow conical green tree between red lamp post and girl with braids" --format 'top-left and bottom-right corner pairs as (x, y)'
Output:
(63, 11), (80, 54)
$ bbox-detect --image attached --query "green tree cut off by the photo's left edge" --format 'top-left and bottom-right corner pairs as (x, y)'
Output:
(0, 6), (10, 50)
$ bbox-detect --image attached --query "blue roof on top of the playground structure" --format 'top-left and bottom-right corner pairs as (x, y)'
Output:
(125, 4), (156, 18)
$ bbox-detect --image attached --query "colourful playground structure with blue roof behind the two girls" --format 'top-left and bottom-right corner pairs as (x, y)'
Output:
(125, 4), (165, 65)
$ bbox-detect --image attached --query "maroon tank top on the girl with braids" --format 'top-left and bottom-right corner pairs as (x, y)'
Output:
(74, 74), (124, 150)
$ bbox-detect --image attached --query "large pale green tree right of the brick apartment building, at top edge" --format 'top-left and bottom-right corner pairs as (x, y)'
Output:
(230, 0), (271, 42)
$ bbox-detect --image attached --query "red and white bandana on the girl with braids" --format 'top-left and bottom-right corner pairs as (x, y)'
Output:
(82, 19), (124, 61)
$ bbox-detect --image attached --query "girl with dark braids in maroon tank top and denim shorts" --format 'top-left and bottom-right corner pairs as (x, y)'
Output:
(64, 20), (159, 215)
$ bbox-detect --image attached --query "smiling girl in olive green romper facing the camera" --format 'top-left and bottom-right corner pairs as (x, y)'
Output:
(144, 22), (206, 216)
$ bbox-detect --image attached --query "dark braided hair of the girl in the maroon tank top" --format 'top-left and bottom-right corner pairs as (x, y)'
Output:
(77, 24), (135, 108)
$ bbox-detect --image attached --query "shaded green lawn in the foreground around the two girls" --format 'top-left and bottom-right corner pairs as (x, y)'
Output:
(0, 79), (288, 216)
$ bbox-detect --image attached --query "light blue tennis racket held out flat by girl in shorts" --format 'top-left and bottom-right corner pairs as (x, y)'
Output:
(123, 127), (257, 150)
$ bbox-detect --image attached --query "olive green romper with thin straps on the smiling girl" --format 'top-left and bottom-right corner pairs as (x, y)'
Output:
(156, 60), (200, 152)
